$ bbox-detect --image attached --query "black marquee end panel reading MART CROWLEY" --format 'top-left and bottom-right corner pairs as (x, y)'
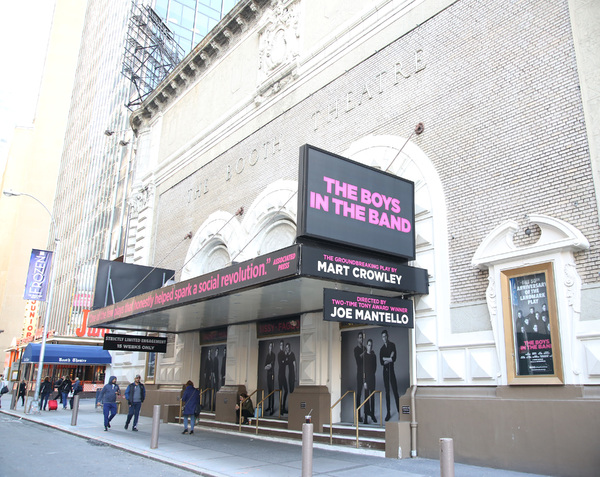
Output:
(301, 244), (429, 294)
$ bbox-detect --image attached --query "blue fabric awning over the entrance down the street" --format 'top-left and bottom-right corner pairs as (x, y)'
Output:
(21, 343), (112, 366)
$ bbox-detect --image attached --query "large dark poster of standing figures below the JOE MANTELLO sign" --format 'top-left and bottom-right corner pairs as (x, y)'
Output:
(341, 326), (410, 426)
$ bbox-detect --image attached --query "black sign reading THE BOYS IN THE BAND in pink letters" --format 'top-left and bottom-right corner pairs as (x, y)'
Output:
(297, 145), (415, 260)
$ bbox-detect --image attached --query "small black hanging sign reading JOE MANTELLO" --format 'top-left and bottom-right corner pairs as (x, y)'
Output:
(323, 288), (414, 328)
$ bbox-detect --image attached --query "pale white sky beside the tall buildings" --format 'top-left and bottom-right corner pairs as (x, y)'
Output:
(0, 0), (55, 173)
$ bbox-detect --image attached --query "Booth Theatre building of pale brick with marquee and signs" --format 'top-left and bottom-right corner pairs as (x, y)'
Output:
(89, 0), (600, 475)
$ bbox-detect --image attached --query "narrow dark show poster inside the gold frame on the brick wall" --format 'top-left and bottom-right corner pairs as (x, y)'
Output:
(509, 272), (554, 376)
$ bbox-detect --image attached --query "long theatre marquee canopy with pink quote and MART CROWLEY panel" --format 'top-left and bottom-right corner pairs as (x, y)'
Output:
(88, 243), (429, 333)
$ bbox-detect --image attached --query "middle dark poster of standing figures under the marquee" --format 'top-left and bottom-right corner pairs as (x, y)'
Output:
(253, 335), (300, 417)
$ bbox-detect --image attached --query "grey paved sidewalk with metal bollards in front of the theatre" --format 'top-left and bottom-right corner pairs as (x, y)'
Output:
(0, 399), (548, 477)
